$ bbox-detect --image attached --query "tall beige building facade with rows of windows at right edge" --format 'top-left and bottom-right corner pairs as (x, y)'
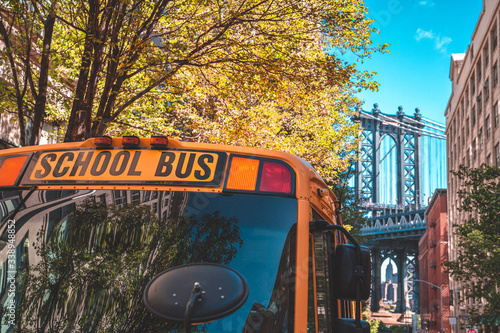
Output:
(446, 0), (500, 332)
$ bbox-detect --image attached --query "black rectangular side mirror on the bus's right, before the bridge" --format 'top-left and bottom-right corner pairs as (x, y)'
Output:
(333, 244), (371, 301)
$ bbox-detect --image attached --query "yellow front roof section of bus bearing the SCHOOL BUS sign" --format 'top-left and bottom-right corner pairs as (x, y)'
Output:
(0, 137), (336, 222)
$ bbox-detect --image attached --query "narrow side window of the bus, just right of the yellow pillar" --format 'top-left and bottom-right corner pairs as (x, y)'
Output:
(307, 209), (336, 333)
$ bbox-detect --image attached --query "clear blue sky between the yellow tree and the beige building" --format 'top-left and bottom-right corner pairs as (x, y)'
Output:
(358, 0), (483, 124)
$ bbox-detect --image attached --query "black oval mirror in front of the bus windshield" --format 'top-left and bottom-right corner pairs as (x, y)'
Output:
(143, 263), (249, 333)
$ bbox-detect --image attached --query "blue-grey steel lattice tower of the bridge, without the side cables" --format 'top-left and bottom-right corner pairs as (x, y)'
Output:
(355, 104), (435, 313)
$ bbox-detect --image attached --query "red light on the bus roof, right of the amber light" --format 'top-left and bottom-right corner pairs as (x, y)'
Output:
(259, 161), (292, 193)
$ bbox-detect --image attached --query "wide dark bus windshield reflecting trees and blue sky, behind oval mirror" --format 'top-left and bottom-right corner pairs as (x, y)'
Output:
(0, 185), (297, 332)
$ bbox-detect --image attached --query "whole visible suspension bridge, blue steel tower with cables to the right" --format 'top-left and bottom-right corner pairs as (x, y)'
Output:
(354, 104), (446, 313)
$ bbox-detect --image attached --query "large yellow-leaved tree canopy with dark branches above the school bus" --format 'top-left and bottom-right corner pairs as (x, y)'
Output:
(0, 0), (385, 175)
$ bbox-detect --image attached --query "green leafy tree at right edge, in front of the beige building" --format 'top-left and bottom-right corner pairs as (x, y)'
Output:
(445, 165), (500, 326)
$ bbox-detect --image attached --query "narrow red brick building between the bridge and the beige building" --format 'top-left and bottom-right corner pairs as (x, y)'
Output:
(418, 189), (451, 333)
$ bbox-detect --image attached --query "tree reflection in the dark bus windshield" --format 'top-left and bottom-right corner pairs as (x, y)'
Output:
(14, 196), (243, 333)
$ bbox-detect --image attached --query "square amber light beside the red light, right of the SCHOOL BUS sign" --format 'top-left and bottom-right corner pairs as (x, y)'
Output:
(226, 157), (259, 191)
